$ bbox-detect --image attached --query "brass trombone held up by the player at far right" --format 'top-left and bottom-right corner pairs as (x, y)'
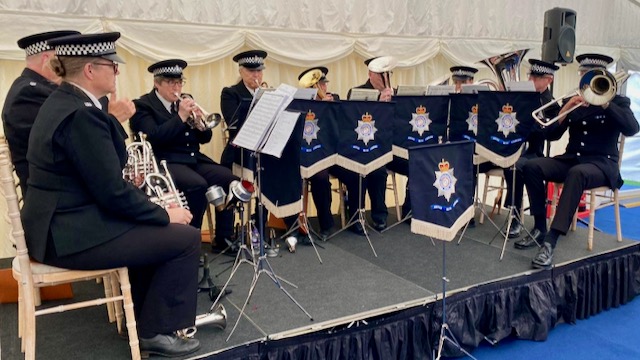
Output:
(531, 69), (629, 127)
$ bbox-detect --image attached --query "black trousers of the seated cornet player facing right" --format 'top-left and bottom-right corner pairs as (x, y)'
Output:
(167, 162), (239, 239)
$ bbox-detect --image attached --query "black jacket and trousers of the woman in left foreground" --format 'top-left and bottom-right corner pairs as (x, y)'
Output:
(22, 83), (200, 335)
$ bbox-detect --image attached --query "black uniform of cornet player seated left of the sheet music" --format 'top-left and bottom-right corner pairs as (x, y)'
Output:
(129, 90), (238, 243)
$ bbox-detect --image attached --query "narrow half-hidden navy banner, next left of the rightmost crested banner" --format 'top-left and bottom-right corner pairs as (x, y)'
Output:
(447, 94), (478, 141)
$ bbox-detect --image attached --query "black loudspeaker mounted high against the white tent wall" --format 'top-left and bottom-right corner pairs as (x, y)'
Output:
(542, 8), (576, 64)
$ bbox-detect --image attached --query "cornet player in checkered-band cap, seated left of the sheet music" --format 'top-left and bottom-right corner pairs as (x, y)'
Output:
(130, 59), (239, 250)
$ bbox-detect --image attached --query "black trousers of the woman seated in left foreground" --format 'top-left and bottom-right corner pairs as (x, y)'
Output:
(45, 224), (201, 337)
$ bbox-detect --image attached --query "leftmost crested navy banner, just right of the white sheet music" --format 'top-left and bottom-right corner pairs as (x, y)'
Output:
(288, 100), (340, 179)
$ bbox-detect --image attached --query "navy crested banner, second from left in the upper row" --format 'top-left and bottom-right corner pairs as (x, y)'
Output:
(336, 101), (395, 175)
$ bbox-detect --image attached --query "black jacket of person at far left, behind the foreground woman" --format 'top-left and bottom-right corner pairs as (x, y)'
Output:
(2, 68), (58, 195)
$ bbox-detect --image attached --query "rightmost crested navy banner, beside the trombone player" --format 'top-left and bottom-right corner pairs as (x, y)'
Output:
(476, 91), (540, 168)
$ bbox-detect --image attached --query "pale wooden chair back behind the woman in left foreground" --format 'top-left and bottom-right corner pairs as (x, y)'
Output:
(0, 136), (33, 286)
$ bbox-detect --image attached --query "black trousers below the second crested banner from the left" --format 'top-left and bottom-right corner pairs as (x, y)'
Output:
(329, 166), (389, 223)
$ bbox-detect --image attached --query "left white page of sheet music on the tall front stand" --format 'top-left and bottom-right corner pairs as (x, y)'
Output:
(232, 91), (286, 151)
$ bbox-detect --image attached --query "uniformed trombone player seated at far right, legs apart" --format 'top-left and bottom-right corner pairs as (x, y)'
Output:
(522, 54), (638, 268)
